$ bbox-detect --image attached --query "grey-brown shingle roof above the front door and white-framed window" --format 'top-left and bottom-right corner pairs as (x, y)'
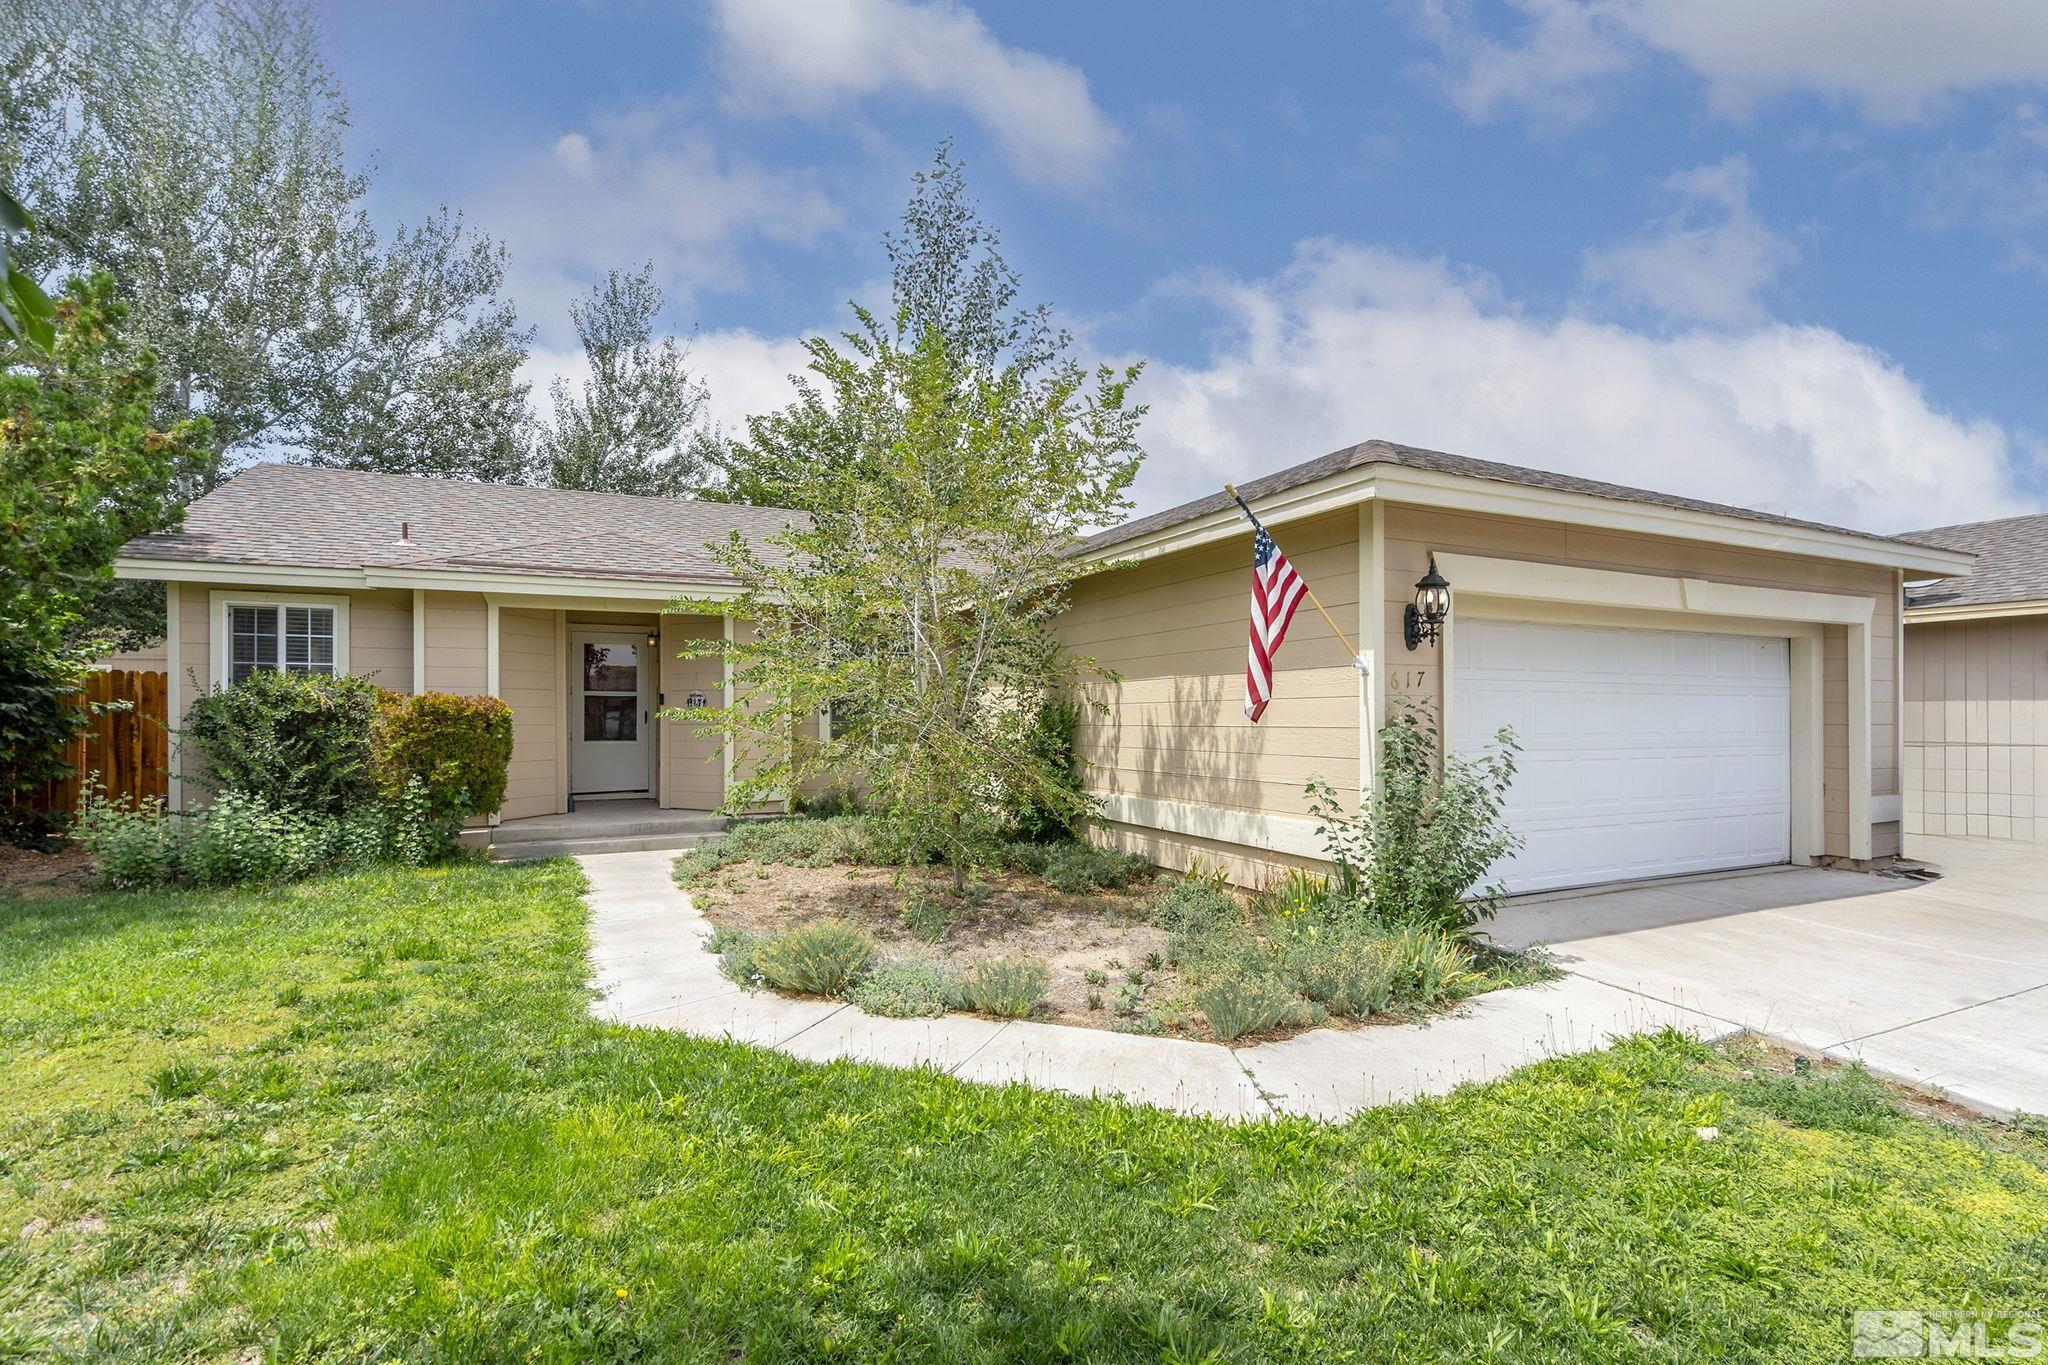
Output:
(123, 465), (799, 583)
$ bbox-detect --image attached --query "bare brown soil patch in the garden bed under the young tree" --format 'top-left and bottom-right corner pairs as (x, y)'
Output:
(690, 862), (1179, 1036)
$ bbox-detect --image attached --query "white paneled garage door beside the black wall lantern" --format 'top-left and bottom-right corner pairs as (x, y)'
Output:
(1450, 618), (1792, 892)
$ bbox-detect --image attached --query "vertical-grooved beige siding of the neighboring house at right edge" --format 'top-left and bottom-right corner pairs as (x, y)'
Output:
(1905, 616), (2048, 841)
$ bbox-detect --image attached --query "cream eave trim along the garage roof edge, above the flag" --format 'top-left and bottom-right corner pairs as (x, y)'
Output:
(1081, 465), (1976, 577)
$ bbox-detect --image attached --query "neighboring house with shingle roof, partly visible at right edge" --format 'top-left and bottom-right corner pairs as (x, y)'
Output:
(1905, 514), (2048, 841)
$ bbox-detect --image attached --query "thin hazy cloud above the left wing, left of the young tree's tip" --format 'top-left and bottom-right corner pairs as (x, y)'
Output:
(477, 104), (844, 338)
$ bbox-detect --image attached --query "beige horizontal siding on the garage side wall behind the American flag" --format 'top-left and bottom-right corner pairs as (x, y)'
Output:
(1059, 510), (1360, 880)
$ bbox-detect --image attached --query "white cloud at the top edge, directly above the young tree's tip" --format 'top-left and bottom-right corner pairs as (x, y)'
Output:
(713, 0), (1122, 188)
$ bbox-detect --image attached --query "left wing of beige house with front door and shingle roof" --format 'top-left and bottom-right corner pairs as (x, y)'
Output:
(115, 465), (793, 819)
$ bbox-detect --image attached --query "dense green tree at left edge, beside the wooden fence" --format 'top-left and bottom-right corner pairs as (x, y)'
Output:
(0, 274), (207, 837)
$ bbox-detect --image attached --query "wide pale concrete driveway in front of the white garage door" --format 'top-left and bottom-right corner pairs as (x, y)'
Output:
(1491, 839), (2048, 1117)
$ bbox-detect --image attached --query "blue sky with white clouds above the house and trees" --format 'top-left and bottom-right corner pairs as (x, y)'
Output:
(322, 0), (2048, 530)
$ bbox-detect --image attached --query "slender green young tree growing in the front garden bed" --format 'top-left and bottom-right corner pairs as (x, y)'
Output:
(688, 147), (1145, 886)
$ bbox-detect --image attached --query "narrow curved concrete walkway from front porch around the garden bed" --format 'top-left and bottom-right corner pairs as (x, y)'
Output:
(578, 851), (1733, 1119)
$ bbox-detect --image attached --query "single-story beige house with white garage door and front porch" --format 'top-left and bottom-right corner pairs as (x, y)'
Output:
(117, 431), (1970, 890)
